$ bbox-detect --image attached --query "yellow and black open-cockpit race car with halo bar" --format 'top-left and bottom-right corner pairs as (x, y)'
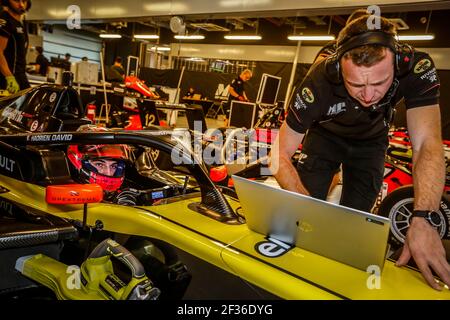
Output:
(0, 130), (450, 300)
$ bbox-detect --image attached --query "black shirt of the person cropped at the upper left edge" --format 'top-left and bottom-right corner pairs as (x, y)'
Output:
(0, 11), (28, 75)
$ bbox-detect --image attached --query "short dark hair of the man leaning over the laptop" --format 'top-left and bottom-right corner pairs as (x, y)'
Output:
(337, 14), (396, 67)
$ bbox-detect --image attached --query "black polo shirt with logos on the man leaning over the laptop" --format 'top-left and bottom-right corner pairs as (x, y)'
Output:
(286, 51), (440, 140)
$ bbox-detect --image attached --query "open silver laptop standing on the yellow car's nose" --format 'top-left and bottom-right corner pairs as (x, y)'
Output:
(233, 176), (389, 271)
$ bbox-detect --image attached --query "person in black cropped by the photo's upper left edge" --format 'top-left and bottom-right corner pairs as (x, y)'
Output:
(0, 0), (31, 93)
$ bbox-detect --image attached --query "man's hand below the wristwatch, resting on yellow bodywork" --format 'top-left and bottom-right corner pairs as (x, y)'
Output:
(396, 217), (450, 291)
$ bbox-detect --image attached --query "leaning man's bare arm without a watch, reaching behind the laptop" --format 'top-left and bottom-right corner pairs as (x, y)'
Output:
(269, 122), (309, 195)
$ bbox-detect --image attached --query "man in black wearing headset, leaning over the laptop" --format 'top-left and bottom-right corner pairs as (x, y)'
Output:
(270, 15), (450, 290)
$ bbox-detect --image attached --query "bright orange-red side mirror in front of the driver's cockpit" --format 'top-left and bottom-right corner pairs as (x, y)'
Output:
(45, 184), (103, 204)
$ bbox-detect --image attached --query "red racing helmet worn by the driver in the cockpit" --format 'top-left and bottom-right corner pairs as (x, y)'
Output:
(67, 125), (130, 192)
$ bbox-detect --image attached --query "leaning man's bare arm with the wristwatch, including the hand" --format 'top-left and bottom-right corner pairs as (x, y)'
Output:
(397, 105), (450, 290)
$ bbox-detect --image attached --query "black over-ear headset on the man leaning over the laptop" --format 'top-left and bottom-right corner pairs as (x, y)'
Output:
(325, 30), (414, 84)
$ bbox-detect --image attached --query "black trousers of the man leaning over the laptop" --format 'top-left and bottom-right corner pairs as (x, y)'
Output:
(297, 127), (388, 212)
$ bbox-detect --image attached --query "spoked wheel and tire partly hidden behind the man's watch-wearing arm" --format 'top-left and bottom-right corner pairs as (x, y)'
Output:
(378, 185), (450, 250)
